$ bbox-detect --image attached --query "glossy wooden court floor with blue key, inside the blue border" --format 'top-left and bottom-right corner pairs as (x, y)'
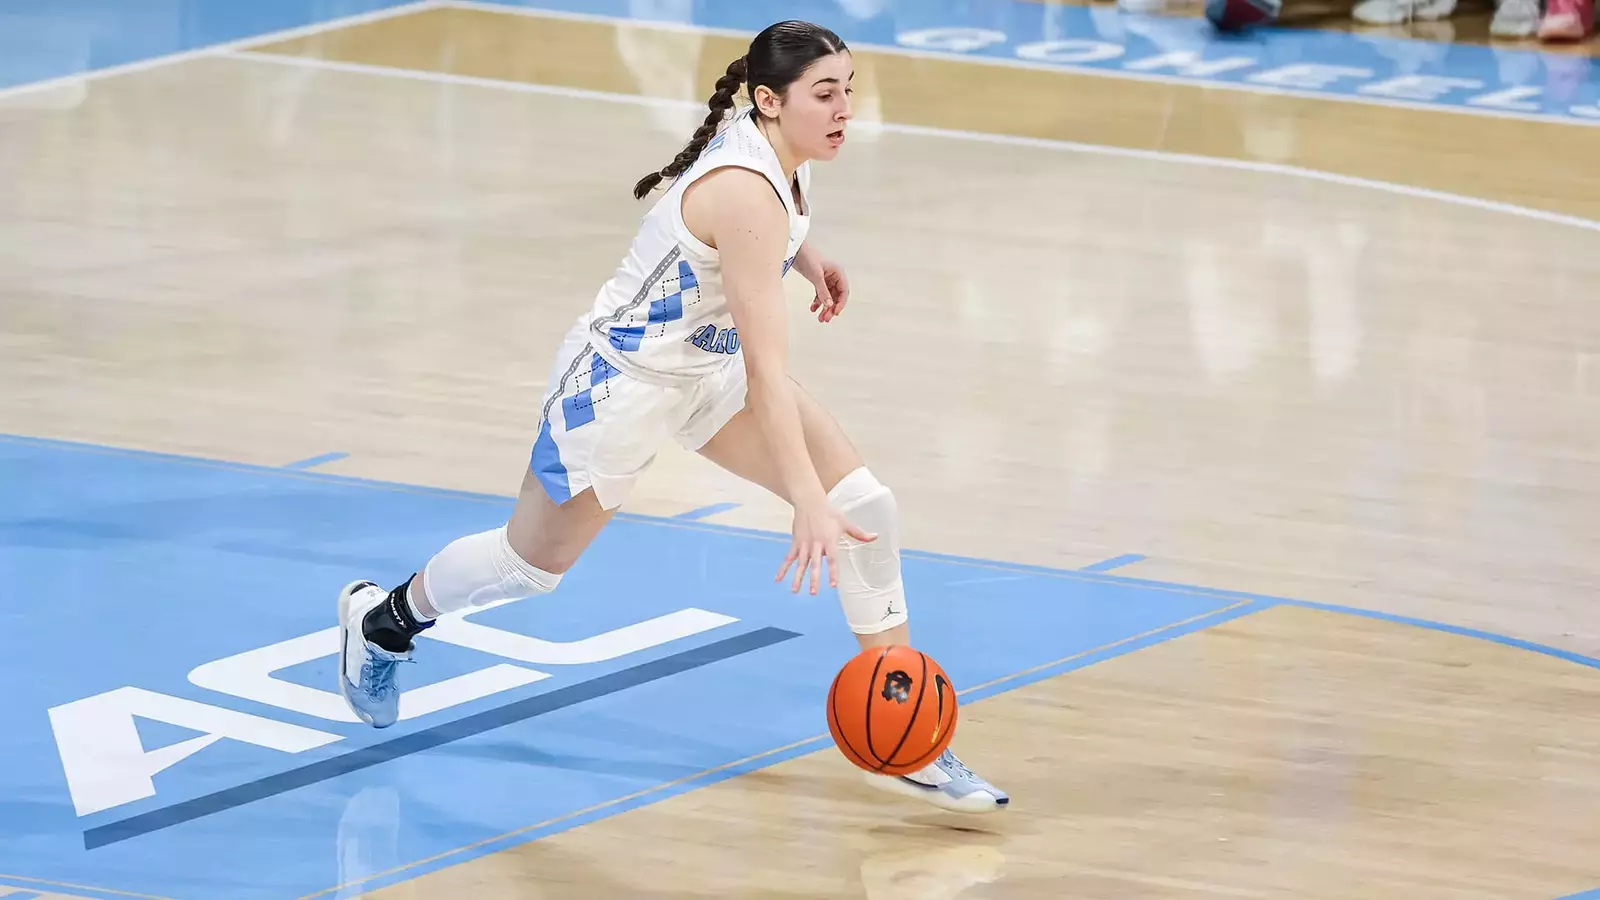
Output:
(0, 3), (1600, 900)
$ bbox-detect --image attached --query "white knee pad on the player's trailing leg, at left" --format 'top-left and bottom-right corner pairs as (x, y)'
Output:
(422, 525), (562, 615)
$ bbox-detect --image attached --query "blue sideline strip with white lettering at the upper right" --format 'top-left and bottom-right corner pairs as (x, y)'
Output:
(477, 0), (1600, 125)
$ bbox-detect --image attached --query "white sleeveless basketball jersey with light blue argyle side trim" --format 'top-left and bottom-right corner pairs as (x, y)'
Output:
(587, 109), (811, 384)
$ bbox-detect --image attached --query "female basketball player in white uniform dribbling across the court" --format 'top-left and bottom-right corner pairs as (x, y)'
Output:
(339, 22), (1010, 812)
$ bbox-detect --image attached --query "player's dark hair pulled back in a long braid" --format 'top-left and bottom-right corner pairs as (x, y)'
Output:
(634, 21), (848, 200)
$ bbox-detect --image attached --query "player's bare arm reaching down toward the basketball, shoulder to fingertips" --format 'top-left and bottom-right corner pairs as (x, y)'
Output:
(683, 167), (870, 593)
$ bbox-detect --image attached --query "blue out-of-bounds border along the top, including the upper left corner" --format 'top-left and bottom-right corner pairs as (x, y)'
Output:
(0, 0), (1600, 125)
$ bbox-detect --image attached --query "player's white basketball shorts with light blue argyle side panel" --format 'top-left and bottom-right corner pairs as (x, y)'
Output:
(530, 320), (746, 509)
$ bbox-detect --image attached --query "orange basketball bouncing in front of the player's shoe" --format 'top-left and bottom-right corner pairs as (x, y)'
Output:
(827, 645), (955, 775)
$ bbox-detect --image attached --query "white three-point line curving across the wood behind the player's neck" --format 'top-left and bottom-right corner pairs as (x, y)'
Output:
(222, 50), (1600, 232)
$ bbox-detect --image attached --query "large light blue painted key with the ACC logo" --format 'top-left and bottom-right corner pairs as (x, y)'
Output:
(0, 439), (1251, 898)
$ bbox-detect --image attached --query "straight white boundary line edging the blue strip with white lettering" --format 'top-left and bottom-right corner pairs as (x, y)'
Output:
(437, 0), (1600, 128)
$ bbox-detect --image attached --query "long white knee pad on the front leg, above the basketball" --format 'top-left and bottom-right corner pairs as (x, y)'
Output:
(827, 468), (906, 634)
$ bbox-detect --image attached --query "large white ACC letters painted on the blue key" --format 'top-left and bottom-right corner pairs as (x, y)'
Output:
(50, 601), (739, 815)
